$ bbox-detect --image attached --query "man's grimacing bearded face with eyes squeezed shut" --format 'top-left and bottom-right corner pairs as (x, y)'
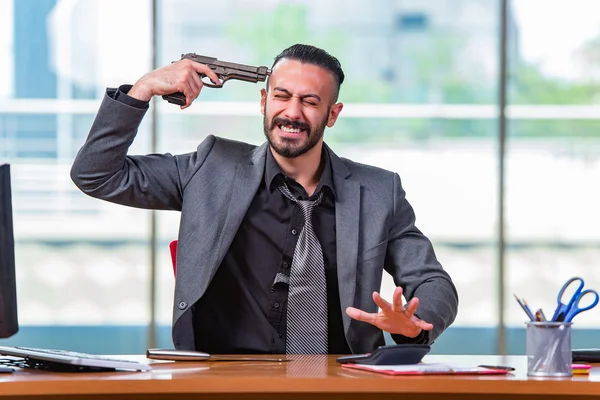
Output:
(261, 59), (342, 158)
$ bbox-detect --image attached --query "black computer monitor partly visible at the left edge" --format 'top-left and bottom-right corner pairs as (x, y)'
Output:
(0, 164), (19, 338)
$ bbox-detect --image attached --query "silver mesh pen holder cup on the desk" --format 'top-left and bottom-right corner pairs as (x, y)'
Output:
(526, 322), (573, 377)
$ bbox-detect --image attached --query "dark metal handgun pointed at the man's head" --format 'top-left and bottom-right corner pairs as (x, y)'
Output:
(163, 53), (271, 106)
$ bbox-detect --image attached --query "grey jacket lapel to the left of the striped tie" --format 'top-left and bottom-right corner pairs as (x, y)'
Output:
(216, 143), (267, 265)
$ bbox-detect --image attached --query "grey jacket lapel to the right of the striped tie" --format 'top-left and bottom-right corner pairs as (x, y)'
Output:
(325, 145), (360, 335)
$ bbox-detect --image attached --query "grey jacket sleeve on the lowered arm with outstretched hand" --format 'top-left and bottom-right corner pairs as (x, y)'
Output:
(386, 174), (458, 343)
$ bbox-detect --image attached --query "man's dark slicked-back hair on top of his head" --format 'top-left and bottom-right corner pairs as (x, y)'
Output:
(267, 44), (344, 101)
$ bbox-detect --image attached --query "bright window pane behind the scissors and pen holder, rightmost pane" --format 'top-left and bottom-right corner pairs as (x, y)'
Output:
(506, 0), (600, 352)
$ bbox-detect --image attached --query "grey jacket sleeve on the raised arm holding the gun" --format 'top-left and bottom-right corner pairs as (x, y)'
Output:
(71, 89), (214, 210)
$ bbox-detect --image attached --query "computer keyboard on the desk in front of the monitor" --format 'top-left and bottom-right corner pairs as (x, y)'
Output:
(0, 346), (152, 372)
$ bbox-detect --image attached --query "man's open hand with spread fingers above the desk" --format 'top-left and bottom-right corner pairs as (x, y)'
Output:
(346, 287), (433, 337)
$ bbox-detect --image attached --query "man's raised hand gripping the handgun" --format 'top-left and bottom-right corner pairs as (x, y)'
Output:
(127, 59), (220, 110)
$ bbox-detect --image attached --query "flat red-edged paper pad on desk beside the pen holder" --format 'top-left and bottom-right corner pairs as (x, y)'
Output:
(342, 363), (509, 375)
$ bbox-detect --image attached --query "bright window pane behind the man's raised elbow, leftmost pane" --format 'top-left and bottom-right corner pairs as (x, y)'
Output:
(0, 0), (151, 352)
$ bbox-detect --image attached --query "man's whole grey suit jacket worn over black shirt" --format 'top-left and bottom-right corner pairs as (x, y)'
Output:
(71, 90), (458, 353)
